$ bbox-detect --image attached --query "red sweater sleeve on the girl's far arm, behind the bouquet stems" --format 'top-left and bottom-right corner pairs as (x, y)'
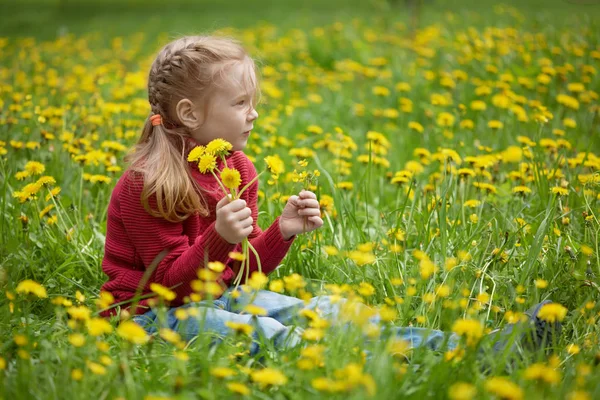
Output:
(227, 158), (295, 282)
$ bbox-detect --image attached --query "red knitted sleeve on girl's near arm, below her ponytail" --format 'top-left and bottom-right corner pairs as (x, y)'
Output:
(119, 178), (235, 305)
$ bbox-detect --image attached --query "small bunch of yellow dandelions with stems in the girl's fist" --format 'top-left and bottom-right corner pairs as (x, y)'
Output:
(188, 139), (262, 288)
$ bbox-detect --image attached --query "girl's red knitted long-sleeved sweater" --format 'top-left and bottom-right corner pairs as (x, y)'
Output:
(101, 151), (294, 317)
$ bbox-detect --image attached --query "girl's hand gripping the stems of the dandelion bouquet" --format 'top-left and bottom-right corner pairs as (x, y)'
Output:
(215, 196), (254, 244)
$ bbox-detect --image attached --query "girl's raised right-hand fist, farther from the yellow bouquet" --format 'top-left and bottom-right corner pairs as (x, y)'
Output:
(279, 190), (323, 240)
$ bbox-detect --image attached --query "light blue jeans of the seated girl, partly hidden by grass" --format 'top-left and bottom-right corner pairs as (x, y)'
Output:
(134, 288), (459, 354)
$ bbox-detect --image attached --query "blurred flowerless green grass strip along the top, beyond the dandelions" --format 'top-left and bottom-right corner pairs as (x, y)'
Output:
(0, 0), (600, 39)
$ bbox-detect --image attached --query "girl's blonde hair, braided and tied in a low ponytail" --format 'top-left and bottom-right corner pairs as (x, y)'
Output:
(126, 36), (257, 222)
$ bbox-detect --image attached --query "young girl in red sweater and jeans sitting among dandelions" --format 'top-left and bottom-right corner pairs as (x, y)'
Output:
(102, 36), (560, 353)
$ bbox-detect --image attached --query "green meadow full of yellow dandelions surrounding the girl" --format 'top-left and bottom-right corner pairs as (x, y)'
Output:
(0, 2), (600, 400)
